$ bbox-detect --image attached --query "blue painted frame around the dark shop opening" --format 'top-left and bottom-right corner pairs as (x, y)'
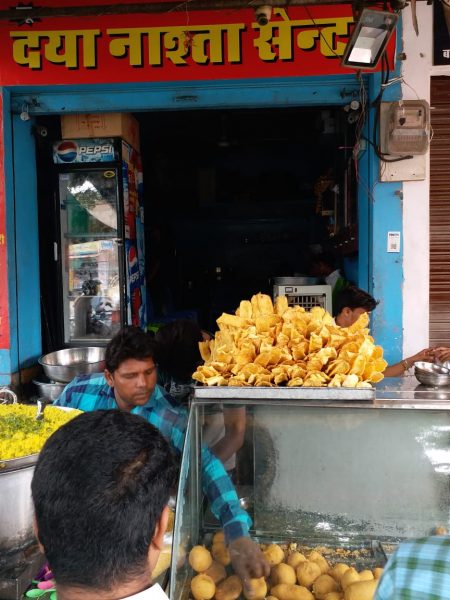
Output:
(2, 75), (402, 367)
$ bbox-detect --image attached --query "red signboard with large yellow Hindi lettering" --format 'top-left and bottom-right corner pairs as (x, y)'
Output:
(0, 4), (395, 85)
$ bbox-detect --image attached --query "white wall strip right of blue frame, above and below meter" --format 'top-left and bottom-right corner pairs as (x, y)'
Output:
(402, 2), (450, 356)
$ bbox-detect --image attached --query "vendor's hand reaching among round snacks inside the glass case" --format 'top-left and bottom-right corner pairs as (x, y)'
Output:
(228, 536), (270, 598)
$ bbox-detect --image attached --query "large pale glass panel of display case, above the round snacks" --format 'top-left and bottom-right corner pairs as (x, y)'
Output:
(253, 405), (450, 543)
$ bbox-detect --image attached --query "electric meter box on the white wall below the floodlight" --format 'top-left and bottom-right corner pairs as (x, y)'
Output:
(385, 100), (430, 156)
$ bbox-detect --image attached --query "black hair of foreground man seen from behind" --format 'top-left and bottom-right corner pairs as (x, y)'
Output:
(31, 410), (176, 590)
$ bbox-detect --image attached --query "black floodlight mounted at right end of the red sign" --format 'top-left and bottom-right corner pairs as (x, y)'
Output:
(341, 8), (398, 69)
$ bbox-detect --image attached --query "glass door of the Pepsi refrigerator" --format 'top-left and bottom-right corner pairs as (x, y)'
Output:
(59, 169), (123, 345)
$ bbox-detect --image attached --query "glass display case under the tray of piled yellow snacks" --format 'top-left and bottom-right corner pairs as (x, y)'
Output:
(170, 387), (450, 600)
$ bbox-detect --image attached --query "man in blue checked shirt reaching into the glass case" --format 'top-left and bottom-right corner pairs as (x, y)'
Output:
(55, 327), (269, 594)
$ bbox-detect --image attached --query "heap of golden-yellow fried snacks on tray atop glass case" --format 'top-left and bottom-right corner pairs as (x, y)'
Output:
(193, 294), (387, 388)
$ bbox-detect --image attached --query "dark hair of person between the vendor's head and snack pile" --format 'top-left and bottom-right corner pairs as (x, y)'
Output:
(155, 319), (203, 382)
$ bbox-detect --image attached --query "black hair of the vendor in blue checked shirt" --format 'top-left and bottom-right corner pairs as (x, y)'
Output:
(105, 327), (155, 373)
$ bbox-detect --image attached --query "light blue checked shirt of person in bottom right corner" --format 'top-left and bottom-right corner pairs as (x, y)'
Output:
(374, 535), (450, 600)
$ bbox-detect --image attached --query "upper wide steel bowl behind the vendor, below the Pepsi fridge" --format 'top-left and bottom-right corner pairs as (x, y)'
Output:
(39, 346), (105, 383)
